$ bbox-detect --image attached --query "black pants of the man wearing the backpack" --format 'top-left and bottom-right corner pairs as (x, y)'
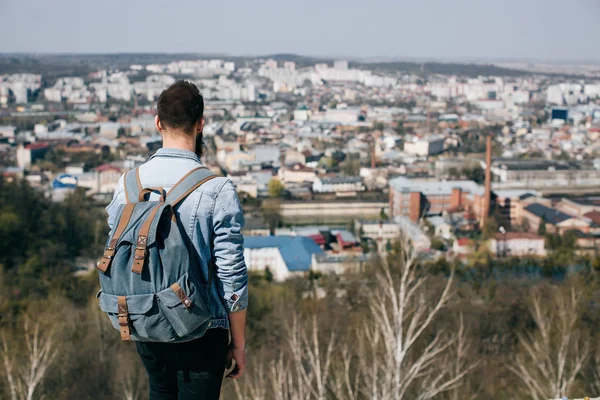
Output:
(137, 329), (229, 400)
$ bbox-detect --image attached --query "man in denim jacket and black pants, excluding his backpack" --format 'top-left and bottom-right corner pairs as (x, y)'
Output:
(107, 81), (248, 400)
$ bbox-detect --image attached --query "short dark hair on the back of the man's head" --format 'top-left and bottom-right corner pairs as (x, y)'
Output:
(157, 81), (204, 134)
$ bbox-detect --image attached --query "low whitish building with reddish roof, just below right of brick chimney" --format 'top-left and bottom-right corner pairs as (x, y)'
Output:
(489, 232), (546, 257)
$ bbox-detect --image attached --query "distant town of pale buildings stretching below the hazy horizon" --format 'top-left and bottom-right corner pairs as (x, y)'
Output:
(0, 53), (600, 281)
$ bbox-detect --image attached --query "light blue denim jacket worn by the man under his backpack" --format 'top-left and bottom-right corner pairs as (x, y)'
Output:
(106, 149), (248, 328)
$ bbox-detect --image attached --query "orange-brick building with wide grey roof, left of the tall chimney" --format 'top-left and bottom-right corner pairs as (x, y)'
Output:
(389, 177), (485, 221)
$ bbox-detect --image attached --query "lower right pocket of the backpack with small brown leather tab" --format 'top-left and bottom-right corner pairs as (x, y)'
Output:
(156, 273), (210, 338)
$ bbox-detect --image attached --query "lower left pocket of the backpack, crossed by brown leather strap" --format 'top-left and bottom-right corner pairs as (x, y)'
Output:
(98, 291), (177, 342)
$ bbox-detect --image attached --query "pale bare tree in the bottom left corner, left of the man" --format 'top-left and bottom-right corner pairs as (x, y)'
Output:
(2, 318), (57, 400)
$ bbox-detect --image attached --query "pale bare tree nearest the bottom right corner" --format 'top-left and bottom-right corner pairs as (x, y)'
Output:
(509, 287), (590, 399)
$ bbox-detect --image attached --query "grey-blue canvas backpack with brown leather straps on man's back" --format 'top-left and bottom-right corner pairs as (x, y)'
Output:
(97, 167), (217, 342)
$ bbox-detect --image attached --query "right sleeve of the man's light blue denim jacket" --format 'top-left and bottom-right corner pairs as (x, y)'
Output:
(213, 181), (248, 312)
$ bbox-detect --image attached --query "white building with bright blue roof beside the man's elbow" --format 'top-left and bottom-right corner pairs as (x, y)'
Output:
(244, 236), (324, 282)
